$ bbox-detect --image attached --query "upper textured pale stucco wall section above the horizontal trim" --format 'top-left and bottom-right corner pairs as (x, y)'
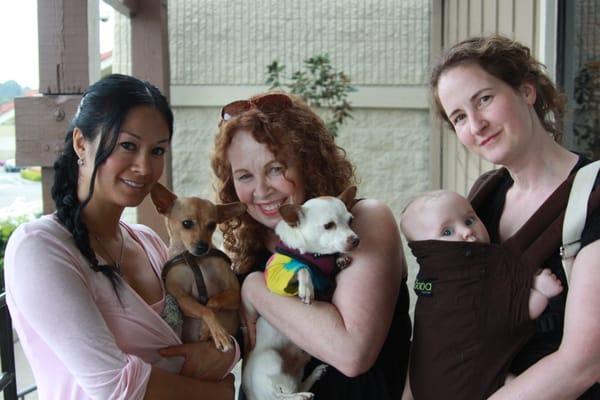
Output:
(169, 0), (429, 85)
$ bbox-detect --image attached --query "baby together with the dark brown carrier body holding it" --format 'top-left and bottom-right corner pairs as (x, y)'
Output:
(400, 190), (562, 400)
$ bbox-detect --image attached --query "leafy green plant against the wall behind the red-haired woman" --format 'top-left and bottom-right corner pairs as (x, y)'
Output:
(267, 54), (356, 136)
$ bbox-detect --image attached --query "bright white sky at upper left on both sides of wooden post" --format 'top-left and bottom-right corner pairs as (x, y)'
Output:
(0, 0), (114, 89)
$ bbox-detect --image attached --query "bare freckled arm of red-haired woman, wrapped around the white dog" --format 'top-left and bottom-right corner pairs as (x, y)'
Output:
(242, 200), (406, 376)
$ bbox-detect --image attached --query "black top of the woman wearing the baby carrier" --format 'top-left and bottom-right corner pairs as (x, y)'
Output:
(478, 157), (600, 399)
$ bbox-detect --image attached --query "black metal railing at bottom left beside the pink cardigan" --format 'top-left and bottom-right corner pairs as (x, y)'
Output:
(0, 290), (37, 400)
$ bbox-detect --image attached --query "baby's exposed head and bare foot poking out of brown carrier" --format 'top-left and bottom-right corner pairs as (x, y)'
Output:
(400, 190), (562, 319)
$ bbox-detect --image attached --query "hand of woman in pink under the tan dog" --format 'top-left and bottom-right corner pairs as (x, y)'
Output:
(158, 341), (235, 381)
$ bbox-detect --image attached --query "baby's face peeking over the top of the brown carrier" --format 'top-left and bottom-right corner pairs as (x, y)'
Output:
(413, 193), (490, 243)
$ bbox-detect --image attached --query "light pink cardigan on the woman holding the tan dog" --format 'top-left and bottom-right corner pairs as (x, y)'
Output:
(5, 215), (183, 400)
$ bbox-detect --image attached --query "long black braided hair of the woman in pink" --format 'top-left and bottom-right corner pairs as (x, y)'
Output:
(51, 74), (173, 296)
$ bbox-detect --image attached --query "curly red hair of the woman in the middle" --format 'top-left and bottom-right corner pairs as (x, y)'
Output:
(211, 94), (356, 273)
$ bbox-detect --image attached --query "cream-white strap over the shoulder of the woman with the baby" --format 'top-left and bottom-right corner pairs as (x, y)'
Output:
(560, 160), (600, 282)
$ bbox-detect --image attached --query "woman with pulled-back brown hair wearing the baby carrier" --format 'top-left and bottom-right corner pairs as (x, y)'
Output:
(430, 36), (600, 399)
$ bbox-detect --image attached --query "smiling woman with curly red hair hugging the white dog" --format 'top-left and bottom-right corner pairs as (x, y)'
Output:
(212, 93), (411, 399)
